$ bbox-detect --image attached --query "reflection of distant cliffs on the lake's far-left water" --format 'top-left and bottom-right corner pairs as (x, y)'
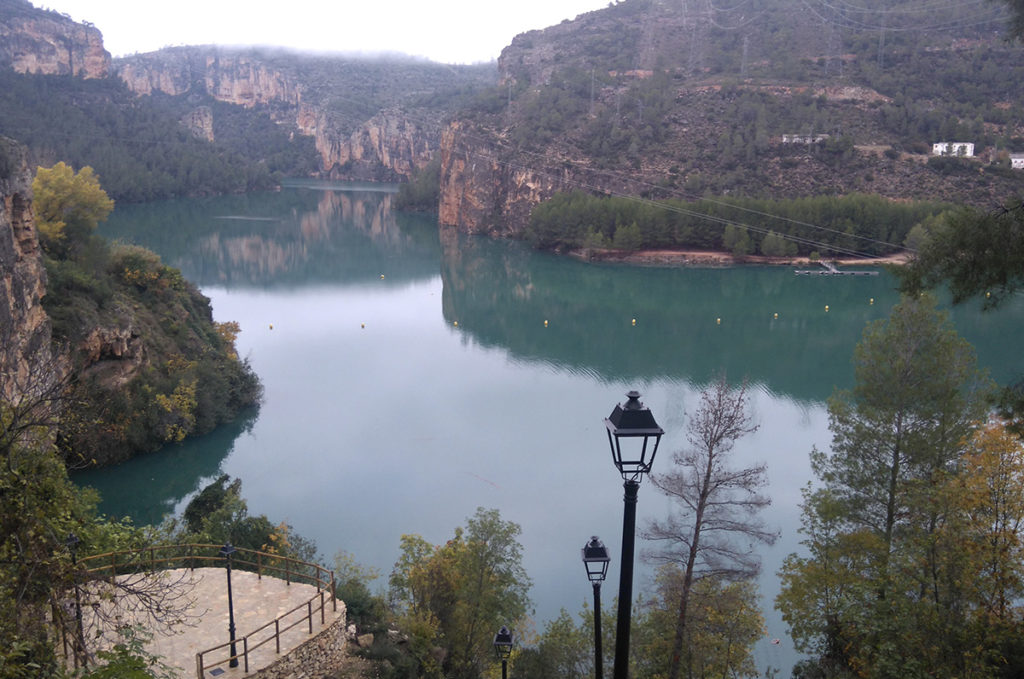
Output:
(101, 185), (438, 288)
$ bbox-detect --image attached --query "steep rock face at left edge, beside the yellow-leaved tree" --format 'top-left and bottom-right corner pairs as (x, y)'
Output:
(0, 137), (50, 400)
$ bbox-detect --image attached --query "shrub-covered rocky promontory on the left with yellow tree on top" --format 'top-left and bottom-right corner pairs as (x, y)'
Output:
(35, 164), (261, 465)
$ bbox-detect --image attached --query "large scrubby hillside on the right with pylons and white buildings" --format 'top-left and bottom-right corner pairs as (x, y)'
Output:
(439, 0), (1024, 242)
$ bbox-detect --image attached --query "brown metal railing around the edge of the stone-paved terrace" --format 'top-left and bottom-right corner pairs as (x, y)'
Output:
(79, 544), (338, 679)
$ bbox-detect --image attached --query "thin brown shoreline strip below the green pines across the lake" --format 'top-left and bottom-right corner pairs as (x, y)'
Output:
(566, 249), (910, 268)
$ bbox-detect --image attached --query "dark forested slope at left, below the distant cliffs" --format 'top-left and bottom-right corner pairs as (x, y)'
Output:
(0, 70), (284, 202)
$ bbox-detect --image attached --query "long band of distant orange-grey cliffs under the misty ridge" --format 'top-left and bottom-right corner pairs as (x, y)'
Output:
(117, 47), (439, 181)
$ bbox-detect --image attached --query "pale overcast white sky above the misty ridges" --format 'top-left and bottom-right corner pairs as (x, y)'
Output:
(33, 0), (608, 63)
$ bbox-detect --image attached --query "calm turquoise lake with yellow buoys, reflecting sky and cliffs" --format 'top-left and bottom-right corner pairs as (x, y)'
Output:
(75, 182), (1024, 676)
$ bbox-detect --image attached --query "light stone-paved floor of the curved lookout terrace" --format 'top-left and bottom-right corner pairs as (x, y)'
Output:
(72, 568), (345, 679)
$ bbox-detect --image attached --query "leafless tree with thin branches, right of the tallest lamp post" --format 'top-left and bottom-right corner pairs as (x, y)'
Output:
(644, 376), (778, 679)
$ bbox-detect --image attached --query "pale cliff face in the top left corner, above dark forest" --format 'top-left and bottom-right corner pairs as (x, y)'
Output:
(0, 0), (111, 78)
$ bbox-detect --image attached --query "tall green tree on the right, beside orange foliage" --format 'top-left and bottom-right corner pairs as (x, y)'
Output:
(776, 295), (1021, 678)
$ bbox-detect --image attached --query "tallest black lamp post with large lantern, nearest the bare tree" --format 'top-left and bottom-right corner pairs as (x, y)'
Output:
(604, 391), (665, 679)
